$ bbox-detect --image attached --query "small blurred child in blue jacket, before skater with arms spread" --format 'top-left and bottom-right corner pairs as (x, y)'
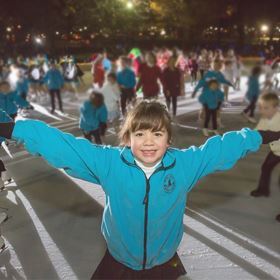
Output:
(199, 80), (224, 137)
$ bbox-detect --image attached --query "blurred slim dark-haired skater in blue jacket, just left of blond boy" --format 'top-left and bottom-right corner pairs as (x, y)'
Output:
(242, 66), (261, 123)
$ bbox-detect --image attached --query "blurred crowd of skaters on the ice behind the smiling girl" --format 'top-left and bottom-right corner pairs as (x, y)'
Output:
(0, 48), (280, 254)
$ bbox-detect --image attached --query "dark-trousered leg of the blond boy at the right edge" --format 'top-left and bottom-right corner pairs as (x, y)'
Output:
(251, 152), (280, 197)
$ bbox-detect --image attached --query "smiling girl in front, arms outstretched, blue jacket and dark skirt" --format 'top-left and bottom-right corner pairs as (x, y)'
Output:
(0, 101), (280, 279)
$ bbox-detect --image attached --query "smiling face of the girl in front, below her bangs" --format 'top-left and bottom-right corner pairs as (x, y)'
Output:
(129, 129), (169, 167)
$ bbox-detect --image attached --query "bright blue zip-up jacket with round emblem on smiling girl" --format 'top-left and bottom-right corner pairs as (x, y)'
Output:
(9, 120), (262, 270)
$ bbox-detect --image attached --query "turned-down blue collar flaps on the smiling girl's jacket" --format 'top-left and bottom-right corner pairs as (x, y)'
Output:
(121, 147), (176, 169)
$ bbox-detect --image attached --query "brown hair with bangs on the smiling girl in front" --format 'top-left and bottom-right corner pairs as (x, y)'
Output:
(119, 101), (172, 146)
